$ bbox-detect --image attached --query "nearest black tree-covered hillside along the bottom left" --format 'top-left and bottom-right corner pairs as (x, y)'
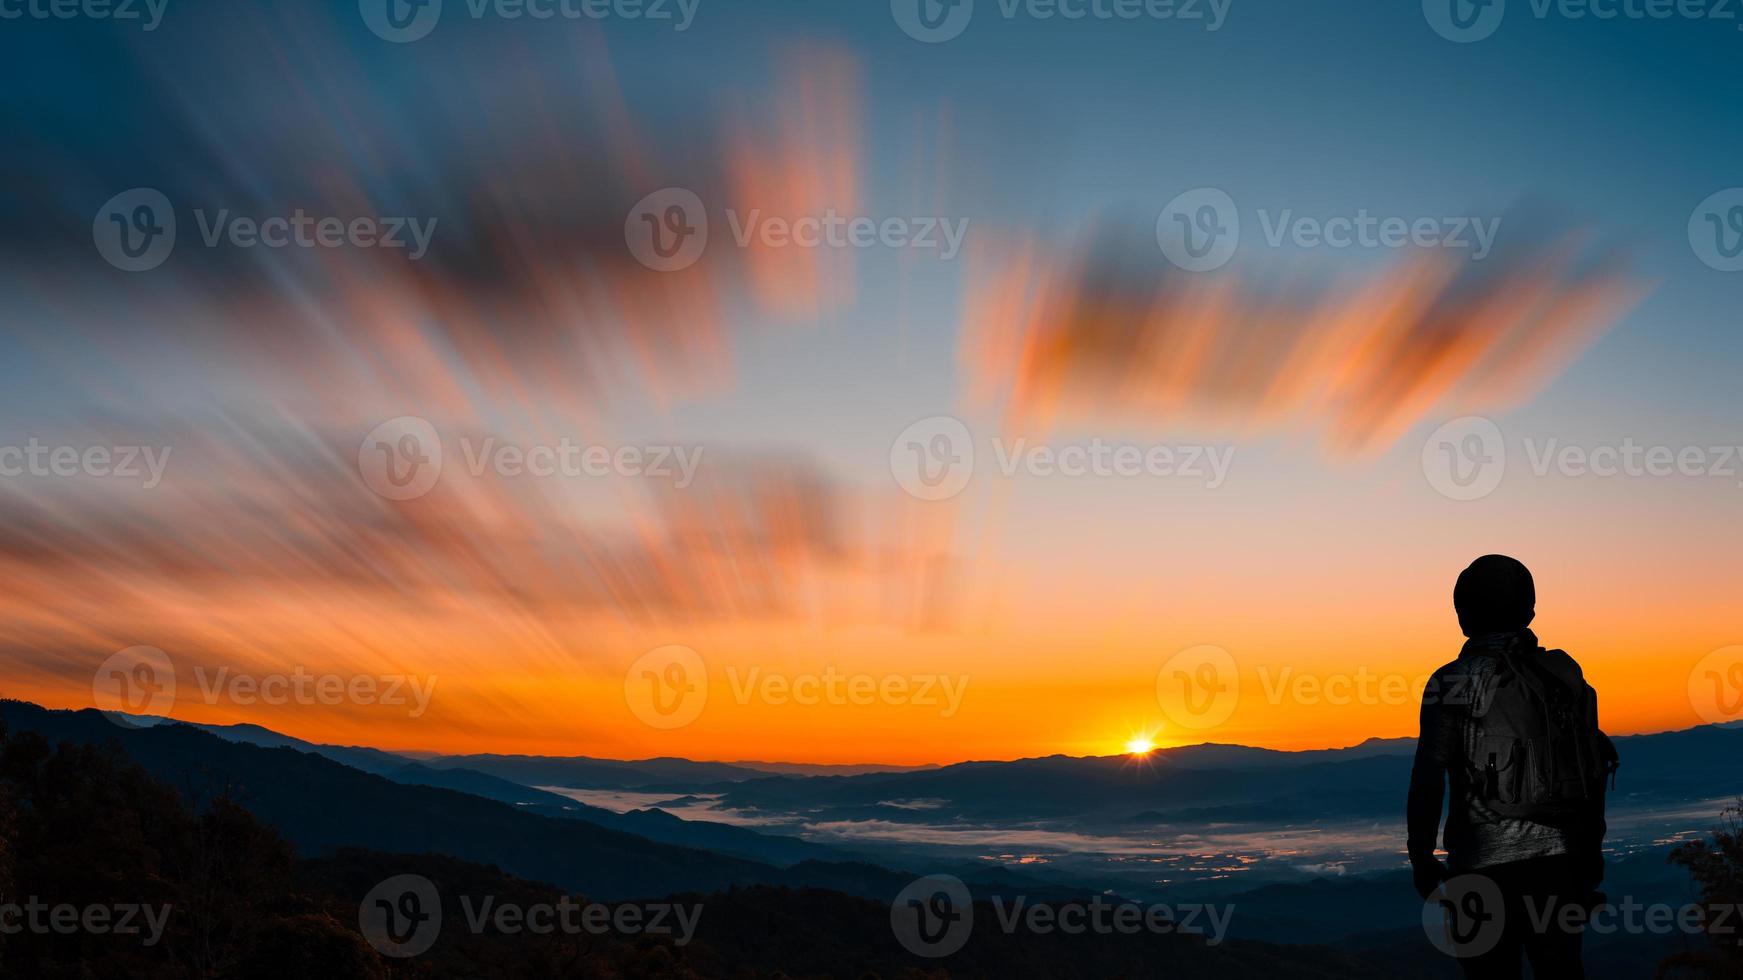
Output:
(0, 704), (1384, 980)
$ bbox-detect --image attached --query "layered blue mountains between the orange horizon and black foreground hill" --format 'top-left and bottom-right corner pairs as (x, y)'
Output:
(0, 701), (1743, 977)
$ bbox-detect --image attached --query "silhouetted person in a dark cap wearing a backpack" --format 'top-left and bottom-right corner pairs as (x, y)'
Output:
(1407, 555), (1616, 980)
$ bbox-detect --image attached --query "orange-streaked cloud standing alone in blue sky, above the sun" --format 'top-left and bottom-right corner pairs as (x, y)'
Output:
(962, 218), (1640, 455)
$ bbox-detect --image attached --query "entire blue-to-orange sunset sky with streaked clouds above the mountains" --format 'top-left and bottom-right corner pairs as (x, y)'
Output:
(0, 0), (1743, 764)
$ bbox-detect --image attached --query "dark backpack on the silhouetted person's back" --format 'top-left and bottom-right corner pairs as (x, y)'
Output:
(1468, 650), (1621, 828)
